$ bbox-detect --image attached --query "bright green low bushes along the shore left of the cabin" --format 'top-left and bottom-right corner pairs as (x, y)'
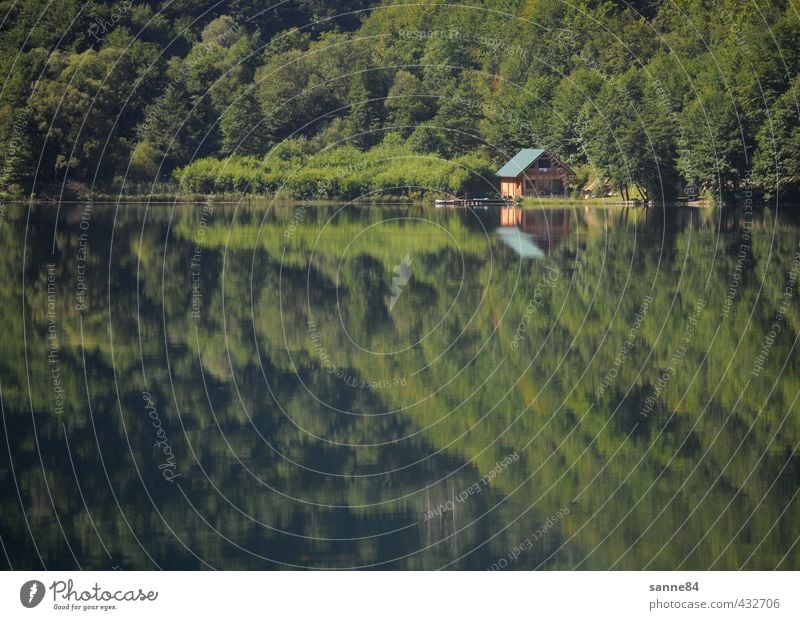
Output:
(175, 141), (495, 200)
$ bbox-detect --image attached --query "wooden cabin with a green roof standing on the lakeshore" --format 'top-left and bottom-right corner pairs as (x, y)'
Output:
(495, 149), (575, 198)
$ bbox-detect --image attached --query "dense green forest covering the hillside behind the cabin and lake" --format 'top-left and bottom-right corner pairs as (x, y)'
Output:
(0, 0), (800, 200)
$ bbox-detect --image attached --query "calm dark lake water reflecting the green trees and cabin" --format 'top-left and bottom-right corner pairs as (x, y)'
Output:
(0, 204), (800, 569)
